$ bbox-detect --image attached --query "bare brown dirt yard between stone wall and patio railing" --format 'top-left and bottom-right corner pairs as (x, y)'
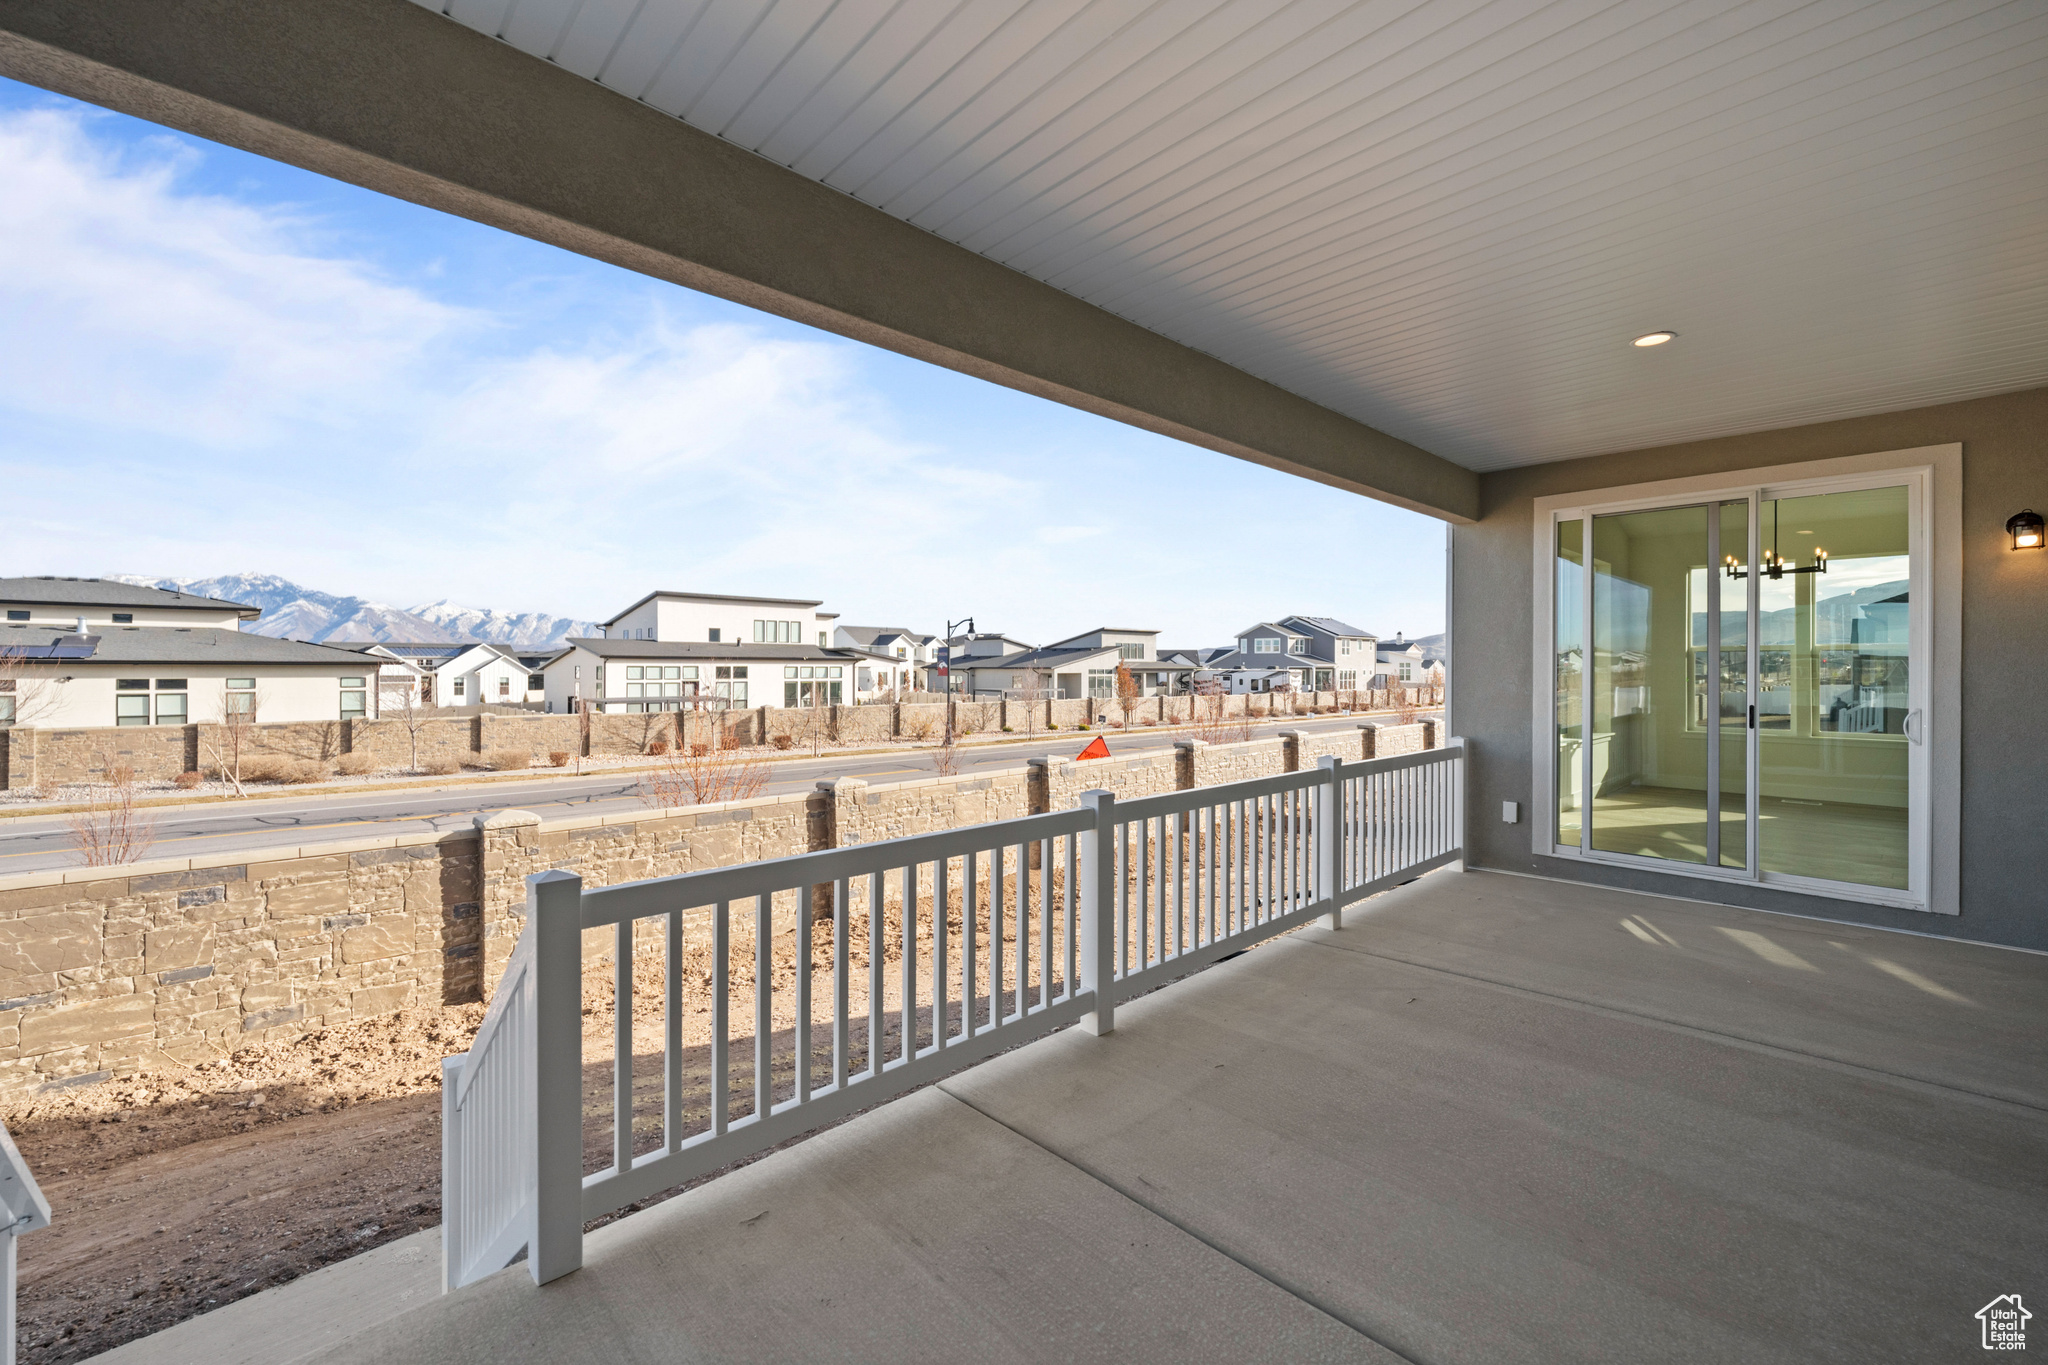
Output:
(0, 859), (1105, 1365)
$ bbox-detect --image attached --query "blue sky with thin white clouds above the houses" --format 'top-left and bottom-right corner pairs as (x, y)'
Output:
(0, 80), (1444, 645)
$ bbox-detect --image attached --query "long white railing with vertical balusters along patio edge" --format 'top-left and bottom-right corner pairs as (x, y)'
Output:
(442, 741), (1464, 1289)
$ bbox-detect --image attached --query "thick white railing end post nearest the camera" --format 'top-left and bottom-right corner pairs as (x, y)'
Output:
(526, 872), (584, 1285)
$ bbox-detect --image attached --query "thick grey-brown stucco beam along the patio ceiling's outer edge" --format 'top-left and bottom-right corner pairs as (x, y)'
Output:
(0, 0), (1479, 522)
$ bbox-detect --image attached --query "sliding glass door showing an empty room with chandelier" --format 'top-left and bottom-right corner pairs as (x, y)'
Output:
(1552, 474), (1925, 890)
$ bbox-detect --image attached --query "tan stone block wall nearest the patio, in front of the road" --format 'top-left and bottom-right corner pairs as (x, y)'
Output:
(0, 714), (1438, 1095)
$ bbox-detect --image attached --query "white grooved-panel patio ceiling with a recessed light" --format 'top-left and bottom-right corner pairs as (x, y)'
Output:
(424, 0), (2048, 469)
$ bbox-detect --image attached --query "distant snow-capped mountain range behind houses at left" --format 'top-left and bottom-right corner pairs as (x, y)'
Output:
(106, 573), (598, 649)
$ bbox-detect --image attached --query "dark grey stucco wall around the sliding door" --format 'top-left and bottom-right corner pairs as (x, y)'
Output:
(1450, 389), (2048, 948)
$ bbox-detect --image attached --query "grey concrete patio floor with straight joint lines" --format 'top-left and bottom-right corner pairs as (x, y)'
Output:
(117, 872), (2048, 1363)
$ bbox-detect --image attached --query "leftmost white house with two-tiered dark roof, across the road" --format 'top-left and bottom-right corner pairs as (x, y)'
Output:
(0, 577), (379, 729)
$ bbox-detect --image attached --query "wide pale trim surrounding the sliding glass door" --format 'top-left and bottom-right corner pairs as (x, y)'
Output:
(1528, 444), (1962, 915)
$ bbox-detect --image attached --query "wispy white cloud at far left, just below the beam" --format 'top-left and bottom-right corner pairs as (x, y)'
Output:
(0, 106), (465, 446)
